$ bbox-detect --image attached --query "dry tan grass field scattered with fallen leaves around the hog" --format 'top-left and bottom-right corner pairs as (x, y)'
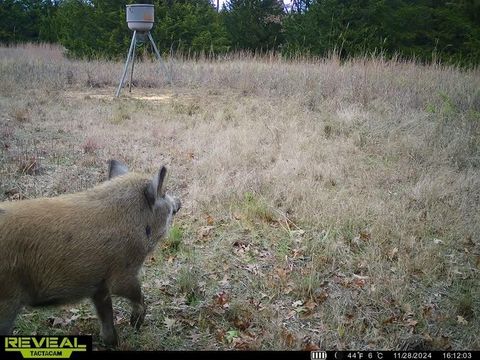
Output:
(0, 45), (480, 350)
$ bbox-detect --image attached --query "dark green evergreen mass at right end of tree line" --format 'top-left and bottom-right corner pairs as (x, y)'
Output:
(283, 0), (480, 65)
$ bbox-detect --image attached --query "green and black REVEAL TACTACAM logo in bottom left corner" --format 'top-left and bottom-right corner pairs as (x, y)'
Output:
(3, 336), (92, 359)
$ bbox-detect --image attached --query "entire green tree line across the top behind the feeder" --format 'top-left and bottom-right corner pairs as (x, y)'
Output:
(0, 0), (480, 66)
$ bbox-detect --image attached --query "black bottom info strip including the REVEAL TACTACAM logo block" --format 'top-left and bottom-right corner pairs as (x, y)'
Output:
(0, 336), (480, 360)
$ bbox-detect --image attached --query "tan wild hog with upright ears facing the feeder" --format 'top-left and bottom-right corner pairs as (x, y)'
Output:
(0, 160), (180, 346)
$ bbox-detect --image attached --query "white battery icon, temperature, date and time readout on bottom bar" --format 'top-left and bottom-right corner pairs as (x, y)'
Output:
(310, 351), (472, 360)
